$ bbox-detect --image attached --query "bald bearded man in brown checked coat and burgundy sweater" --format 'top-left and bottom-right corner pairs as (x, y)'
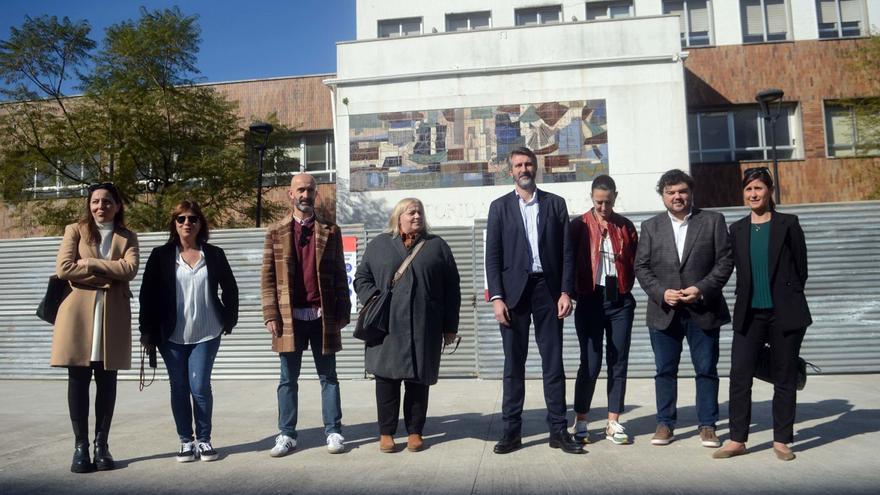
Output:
(260, 174), (351, 457)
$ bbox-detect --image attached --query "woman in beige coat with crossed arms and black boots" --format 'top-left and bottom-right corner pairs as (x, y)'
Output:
(50, 183), (138, 473)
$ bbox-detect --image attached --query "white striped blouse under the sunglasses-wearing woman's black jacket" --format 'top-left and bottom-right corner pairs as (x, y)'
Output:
(168, 248), (223, 344)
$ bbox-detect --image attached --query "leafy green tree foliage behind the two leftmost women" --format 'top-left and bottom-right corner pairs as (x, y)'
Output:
(0, 7), (279, 231)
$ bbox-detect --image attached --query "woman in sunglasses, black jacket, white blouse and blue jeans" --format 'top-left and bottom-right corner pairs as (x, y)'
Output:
(139, 200), (238, 462)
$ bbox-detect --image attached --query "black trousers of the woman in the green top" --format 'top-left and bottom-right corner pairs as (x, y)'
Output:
(729, 310), (804, 443)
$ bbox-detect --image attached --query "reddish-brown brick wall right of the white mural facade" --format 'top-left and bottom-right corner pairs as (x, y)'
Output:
(685, 39), (880, 206)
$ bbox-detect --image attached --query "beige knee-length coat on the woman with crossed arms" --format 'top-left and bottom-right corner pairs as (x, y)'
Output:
(49, 224), (138, 370)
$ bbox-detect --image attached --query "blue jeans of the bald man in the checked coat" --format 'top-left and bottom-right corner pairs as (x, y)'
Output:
(278, 319), (342, 438)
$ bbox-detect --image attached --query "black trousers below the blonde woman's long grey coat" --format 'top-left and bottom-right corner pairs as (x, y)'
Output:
(375, 376), (430, 435)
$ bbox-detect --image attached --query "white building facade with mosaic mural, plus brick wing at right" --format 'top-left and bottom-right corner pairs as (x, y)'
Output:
(326, 0), (880, 225)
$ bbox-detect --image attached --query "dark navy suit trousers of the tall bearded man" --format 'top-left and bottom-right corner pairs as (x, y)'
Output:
(501, 276), (567, 436)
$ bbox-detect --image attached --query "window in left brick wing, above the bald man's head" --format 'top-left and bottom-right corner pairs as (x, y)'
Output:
(263, 131), (336, 185)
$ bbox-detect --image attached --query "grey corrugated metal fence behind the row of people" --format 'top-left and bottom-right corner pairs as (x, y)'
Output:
(0, 202), (880, 379)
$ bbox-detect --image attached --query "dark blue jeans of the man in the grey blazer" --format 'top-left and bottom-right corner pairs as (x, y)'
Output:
(649, 311), (720, 428)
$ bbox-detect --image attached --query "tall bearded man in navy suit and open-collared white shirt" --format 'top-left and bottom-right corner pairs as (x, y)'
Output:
(486, 147), (585, 454)
